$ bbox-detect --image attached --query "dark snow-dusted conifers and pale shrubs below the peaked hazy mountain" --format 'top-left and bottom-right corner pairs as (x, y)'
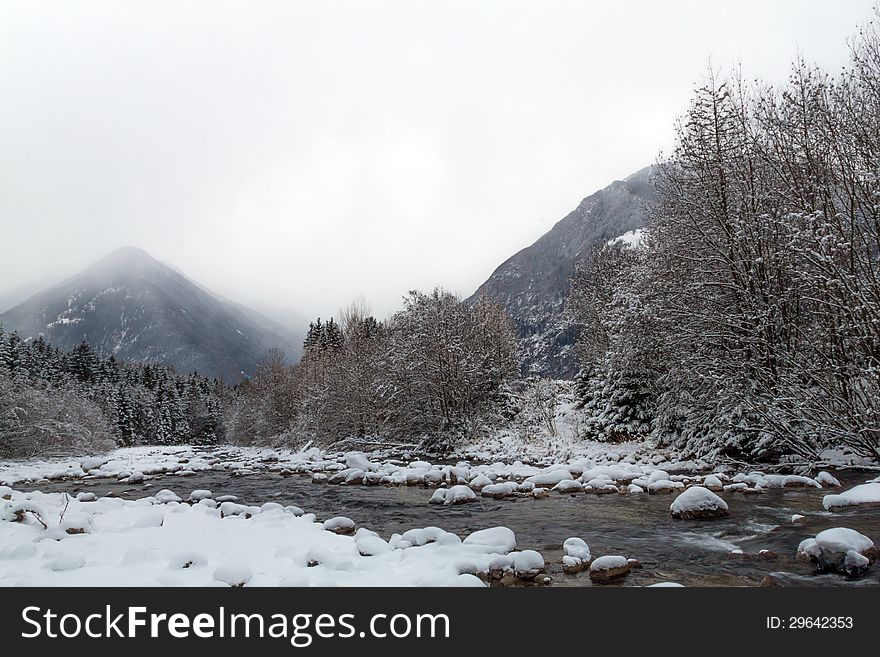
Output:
(0, 327), (225, 458)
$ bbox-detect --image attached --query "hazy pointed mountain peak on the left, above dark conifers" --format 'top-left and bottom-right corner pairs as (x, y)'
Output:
(0, 247), (302, 382)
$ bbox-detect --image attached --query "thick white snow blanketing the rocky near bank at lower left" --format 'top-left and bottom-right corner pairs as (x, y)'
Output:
(0, 490), (544, 586)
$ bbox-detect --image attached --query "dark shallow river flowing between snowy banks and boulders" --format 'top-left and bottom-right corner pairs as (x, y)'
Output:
(16, 471), (880, 586)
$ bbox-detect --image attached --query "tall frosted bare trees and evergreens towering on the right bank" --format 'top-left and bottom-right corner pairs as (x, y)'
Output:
(571, 16), (880, 460)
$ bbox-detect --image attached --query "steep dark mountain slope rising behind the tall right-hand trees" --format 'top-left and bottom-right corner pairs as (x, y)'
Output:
(471, 167), (653, 378)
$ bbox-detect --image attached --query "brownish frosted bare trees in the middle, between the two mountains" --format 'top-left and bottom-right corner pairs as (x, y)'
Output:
(227, 288), (518, 448)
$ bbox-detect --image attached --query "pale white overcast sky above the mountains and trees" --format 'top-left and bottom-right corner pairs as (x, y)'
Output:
(0, 0), (872, 316)
